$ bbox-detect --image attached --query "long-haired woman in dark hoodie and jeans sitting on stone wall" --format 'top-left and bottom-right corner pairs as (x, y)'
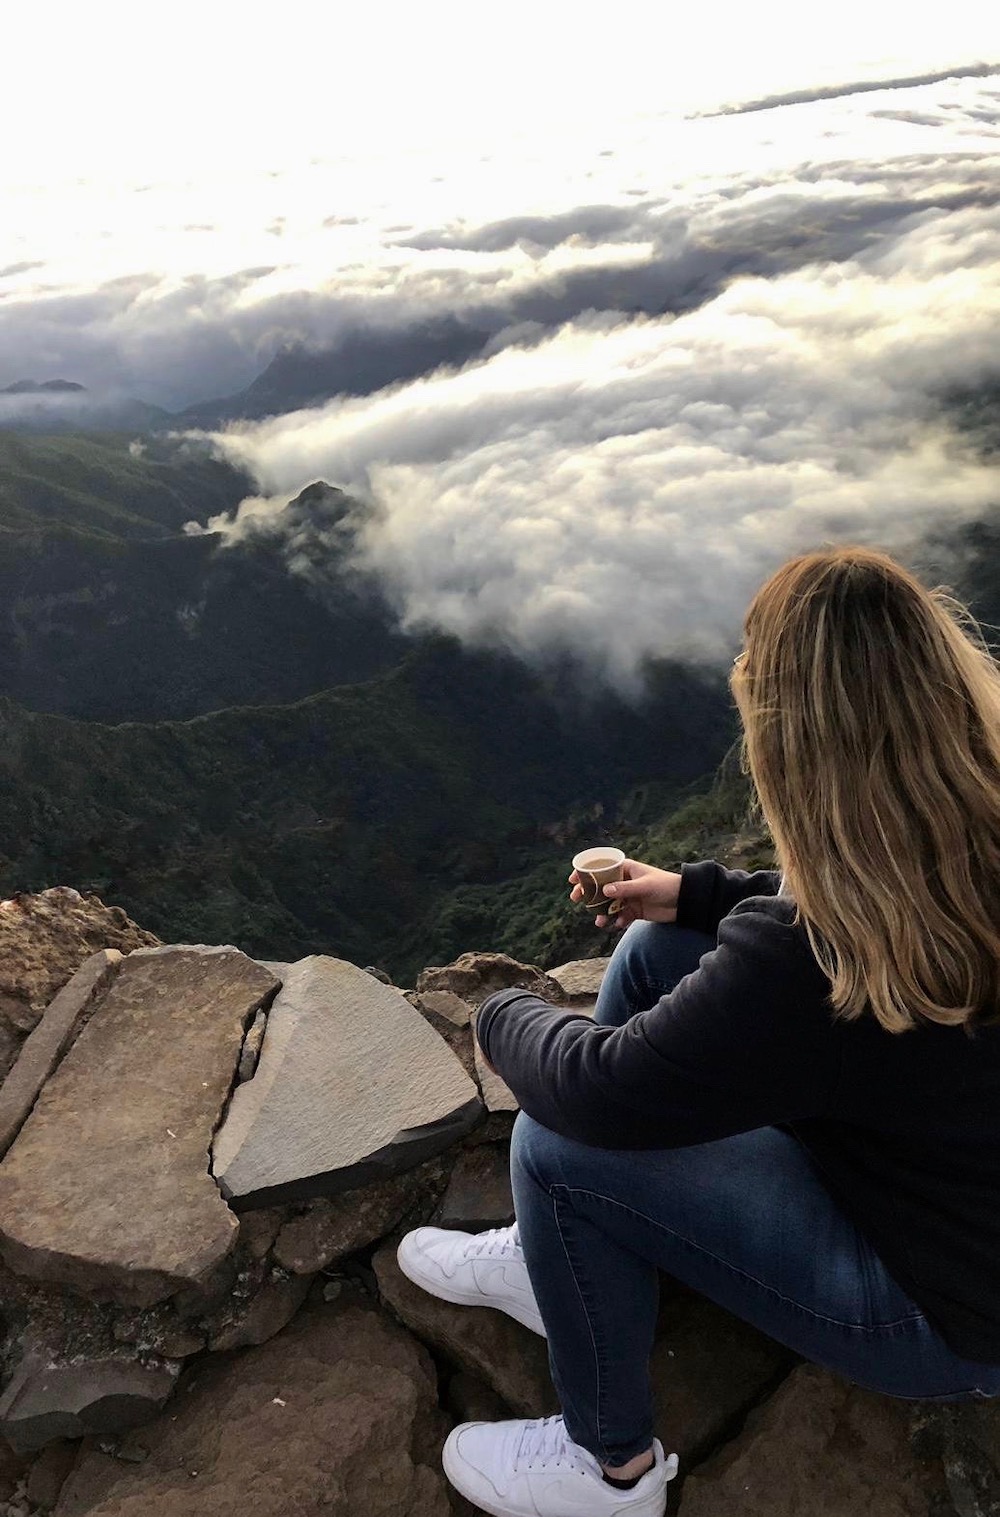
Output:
(399, 548), (1000, 1517)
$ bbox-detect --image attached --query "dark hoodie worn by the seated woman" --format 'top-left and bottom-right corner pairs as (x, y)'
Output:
(476, 863), (1000, 1364)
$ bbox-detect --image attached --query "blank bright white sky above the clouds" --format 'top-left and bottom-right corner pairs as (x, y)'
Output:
(7, 0), (1000, 193)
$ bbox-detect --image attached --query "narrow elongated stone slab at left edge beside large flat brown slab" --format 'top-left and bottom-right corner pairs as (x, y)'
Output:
(0, 948), (121, 1159)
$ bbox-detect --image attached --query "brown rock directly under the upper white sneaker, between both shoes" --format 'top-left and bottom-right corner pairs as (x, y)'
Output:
(372, 1244), (558, 1417)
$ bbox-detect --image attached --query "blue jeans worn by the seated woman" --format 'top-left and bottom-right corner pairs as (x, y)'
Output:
(511, 922), (1000, 1465)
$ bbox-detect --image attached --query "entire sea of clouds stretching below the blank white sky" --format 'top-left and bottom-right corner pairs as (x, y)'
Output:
(0, 71), (1000, 684)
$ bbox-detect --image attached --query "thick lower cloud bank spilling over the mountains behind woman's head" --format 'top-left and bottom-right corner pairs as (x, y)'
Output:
(198, 203), (1000, 683)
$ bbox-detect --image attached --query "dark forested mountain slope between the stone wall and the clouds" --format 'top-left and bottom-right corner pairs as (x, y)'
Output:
(0, 639), (733, 977)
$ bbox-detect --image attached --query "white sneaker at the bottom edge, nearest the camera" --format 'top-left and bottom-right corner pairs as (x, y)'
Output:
(442, 1417), (677, 1517)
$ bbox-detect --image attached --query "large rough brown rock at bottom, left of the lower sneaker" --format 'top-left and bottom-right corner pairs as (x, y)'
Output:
(56, 1292), (449, 1517)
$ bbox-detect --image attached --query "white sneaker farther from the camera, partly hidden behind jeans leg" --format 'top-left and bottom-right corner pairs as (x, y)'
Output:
(396, 1223), (545, 1338)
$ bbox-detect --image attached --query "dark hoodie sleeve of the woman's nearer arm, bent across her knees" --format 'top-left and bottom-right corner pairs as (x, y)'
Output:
(476, 901), (842, 1148)
